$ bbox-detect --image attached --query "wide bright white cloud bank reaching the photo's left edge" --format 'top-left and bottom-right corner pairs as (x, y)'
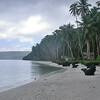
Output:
(0, 15), (50, 43)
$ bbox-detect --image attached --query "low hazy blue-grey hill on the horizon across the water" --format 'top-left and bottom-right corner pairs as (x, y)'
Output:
(0, 51), (30, 59)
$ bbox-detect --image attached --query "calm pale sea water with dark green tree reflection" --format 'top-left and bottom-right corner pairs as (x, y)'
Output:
(0, 60), (60, 92)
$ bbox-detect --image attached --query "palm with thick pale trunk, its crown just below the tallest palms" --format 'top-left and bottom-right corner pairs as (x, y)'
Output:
(78, 15), (93, 59)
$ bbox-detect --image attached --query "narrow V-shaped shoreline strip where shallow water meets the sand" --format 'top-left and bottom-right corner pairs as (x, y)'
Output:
(0, 61), (65, 93)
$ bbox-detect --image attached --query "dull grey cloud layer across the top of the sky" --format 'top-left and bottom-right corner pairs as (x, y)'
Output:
(0, 0), (97, 31)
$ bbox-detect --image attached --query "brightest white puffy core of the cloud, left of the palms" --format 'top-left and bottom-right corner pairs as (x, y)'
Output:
(19, 16), (49, 34)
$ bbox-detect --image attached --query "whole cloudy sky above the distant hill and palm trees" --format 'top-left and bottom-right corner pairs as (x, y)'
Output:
(0, 0), (98, 51)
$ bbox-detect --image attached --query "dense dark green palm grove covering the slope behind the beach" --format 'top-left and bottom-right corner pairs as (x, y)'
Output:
(23, 0), (100, 60)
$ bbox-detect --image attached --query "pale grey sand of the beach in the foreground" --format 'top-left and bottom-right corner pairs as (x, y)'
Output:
(0, 62), (100, 100)
